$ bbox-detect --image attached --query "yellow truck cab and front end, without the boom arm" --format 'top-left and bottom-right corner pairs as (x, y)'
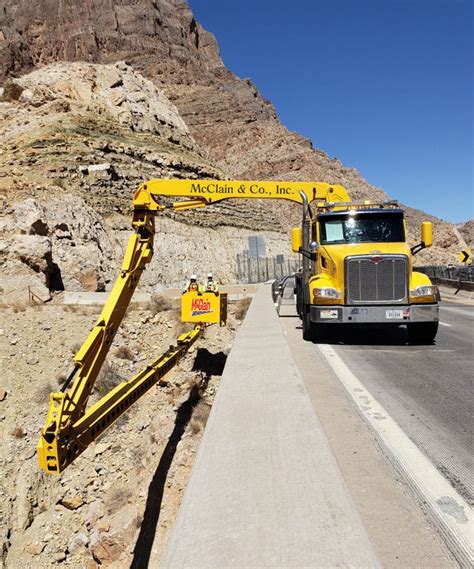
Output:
(292, 191), (439, 344)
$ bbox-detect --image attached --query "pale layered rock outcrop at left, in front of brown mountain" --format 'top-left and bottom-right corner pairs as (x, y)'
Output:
(0, 63), (288, 302)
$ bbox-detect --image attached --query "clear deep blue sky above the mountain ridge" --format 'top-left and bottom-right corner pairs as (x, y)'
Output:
(189, 0), (474, 222)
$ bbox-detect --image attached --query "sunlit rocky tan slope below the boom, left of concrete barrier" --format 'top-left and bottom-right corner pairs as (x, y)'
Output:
(0, 296), (239, 569)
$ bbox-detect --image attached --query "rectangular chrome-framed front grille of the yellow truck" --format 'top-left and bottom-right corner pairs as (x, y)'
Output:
(346, 255), (407, 304)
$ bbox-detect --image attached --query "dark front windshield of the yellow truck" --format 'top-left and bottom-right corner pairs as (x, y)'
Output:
(319, 212), (405, 245)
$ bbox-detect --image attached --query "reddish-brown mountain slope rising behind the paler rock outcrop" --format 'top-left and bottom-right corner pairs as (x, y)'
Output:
(0, 0), (465, 282)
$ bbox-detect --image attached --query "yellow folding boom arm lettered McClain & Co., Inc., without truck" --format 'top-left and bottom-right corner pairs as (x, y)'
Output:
(38, 180), (349, 474)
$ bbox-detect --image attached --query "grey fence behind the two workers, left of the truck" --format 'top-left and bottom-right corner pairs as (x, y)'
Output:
(236, 253), (300, 284)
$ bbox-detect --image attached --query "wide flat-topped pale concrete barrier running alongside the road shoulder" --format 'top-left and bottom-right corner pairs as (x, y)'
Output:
(161, 285), (379, 569)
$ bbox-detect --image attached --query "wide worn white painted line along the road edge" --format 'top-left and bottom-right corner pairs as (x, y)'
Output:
(317, 344), (474, 567)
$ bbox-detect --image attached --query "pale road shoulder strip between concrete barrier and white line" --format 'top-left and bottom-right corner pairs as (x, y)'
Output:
(280, 317), (457, 568)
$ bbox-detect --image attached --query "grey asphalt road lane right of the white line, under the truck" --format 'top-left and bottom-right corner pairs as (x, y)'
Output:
(318, 302), (474, 504)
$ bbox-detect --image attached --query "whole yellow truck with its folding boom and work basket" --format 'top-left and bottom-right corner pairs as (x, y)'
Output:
(38, 180), (438, 474)
